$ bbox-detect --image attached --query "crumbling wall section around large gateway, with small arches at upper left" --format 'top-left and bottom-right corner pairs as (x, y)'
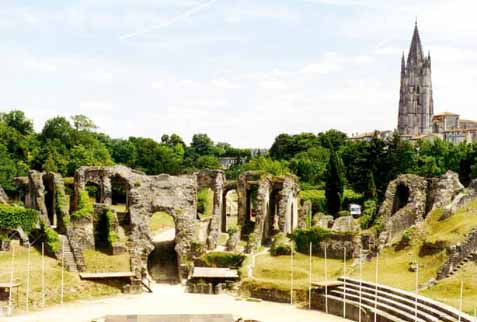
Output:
(74, 166), (199, 281)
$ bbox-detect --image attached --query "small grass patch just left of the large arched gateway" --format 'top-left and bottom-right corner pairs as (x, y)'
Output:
(83, 250), (131, 273)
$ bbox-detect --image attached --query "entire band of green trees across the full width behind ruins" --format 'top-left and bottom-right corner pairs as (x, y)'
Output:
(0, 110), (477, 220)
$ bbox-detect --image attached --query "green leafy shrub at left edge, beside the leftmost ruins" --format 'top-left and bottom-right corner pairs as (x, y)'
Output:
(0, 205), (40, 234)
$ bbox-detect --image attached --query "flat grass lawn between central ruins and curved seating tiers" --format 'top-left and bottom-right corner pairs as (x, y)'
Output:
(247, 253), (351, 290)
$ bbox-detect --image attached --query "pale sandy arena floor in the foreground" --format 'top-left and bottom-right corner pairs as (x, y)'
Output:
(0, 285), (346, 322)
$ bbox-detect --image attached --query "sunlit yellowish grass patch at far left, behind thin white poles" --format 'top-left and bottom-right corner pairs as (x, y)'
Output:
(0, 246), (121, 312)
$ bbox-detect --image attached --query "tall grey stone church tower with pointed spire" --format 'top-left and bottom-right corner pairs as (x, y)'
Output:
(398, 22), (434, 136)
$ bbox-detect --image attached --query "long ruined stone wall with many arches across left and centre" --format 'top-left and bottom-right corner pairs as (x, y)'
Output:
(17, 165), (304, 282)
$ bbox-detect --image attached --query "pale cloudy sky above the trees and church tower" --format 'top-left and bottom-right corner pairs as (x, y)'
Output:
(0, 0), (477, 148)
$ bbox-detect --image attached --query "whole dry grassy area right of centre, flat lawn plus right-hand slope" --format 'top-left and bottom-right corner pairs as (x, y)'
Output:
(247, 200), (477, 313)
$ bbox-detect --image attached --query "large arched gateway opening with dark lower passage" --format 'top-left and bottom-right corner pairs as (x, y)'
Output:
(147, 211), (179, 283)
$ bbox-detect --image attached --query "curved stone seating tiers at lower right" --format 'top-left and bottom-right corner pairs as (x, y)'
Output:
(312, 278), (474, 322)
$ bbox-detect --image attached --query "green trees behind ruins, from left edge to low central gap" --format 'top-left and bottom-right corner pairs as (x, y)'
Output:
(0, 110), (251, 192)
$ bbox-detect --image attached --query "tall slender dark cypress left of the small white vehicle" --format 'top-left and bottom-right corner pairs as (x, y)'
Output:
(325, 148), (345, 216)
